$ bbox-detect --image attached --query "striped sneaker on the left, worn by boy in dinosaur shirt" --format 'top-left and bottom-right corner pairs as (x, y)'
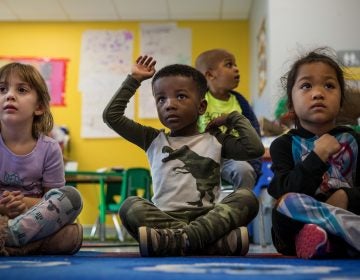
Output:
(139, 226), (187, 257)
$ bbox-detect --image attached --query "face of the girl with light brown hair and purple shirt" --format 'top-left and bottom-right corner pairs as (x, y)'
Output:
(0, 74), (43, 125)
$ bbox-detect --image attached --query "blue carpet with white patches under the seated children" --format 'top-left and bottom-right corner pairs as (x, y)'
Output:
(0, 252), (360, 280)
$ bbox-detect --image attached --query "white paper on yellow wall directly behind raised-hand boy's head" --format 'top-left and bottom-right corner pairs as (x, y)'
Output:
(139, 23), (191, 119)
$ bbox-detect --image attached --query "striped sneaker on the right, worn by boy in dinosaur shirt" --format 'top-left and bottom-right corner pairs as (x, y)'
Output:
(205, 227), (249, 256)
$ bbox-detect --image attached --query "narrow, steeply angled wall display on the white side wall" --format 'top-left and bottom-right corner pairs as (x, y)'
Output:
(257, 20), (267, 96)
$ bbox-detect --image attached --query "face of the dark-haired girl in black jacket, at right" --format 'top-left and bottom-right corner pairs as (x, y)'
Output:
(292, 62), (341, 134)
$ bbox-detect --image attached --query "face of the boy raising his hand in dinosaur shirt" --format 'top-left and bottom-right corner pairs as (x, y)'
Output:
(153, 76), (206, 136)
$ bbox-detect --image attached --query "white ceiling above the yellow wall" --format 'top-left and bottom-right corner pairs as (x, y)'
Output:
(0, 0), (252, 21)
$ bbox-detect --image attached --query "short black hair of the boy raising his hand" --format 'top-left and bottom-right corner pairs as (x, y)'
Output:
(151, 64), (208, 98)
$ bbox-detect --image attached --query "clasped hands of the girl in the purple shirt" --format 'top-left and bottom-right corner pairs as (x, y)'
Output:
(0, 191), (27, 219)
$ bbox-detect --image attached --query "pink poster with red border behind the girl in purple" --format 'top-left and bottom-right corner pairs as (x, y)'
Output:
(0, 56), (68, 106)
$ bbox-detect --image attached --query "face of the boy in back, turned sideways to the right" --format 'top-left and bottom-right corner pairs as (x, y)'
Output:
(206, 55), (240, 91)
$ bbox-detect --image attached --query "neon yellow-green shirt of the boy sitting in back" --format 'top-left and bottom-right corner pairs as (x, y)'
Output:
(198, 91), (242, 132)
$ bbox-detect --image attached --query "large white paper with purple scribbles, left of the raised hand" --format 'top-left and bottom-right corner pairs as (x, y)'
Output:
(79, 30), (134, 138)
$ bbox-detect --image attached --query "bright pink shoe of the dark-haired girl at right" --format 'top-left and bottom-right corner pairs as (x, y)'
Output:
(295, 224), (330, 259)
